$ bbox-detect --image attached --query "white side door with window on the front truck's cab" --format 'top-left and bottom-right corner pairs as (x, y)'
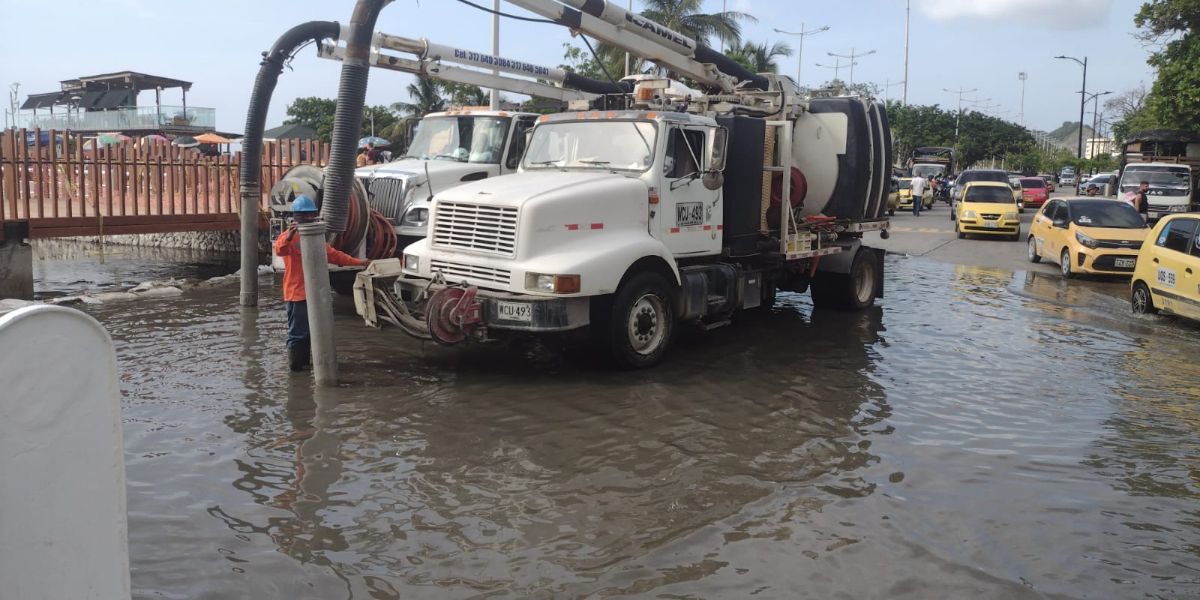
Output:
(652, 125), (722, 256)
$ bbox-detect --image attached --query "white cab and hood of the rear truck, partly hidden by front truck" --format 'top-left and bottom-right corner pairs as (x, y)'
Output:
(354, 108), (539, 239)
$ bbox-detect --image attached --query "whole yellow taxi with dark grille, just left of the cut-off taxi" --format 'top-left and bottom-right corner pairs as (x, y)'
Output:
(1028, 198), (1150, 278)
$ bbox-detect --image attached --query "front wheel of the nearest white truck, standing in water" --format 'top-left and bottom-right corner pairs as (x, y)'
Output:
(600, 271), (674, 368)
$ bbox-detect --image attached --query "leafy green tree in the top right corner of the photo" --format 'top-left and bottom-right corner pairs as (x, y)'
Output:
(1134, 0), (1200, 131)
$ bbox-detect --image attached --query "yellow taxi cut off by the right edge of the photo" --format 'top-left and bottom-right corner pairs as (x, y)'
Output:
(1129, 212), (1200, 320)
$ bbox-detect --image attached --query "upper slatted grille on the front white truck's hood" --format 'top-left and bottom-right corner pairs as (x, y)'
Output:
(433, 202), (517, 257)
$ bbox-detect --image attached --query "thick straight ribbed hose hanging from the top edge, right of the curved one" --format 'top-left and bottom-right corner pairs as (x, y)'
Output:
(320, 0), (391, 233)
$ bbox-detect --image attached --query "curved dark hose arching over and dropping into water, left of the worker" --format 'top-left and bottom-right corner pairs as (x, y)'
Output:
(239, 20), (341, 306)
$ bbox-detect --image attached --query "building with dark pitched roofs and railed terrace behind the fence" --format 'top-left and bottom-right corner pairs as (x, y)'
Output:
(17, 71), (226, 137)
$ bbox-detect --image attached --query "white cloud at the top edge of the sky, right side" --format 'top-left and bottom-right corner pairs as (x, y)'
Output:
(917, 0), (1112, 29)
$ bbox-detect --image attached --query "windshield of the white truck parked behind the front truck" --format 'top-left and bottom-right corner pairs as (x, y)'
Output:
(404, 115), (510, 164)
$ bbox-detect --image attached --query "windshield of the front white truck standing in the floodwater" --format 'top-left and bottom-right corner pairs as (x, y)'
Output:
(522, 120), (656, 172)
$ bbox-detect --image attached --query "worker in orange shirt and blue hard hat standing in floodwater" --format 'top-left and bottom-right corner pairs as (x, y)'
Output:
(275, 196), (370, 371)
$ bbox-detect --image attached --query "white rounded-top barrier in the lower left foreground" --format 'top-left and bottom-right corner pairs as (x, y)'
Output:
(0, 306), (130, 600)
